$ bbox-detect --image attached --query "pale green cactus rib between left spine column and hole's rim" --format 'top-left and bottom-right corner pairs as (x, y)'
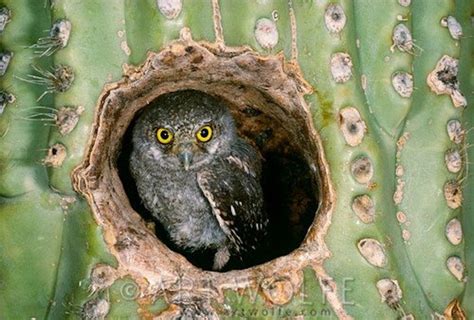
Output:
(48, 1), (129, 194)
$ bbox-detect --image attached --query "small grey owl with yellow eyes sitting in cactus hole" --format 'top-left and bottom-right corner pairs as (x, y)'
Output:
(130, 90), (268, 270)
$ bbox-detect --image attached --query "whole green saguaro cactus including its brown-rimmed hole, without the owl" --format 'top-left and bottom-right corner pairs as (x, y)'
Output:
(0, 0), (474, 319)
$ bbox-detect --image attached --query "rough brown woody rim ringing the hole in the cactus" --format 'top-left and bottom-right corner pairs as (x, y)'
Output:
(72, 30), (337, 310)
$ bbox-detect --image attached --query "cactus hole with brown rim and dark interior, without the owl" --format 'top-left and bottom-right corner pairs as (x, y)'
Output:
(73, 33), (334, 304)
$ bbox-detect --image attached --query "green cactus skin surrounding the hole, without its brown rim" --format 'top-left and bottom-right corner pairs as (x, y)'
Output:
(0, 0), (474, 319)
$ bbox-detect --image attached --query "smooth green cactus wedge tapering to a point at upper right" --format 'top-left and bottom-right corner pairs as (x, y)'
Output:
(351, 1), (412, 135)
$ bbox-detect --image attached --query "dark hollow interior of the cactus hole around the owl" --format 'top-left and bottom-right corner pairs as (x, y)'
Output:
(117, 87), (320, 271)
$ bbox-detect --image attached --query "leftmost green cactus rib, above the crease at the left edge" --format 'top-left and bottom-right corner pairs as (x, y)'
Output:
(0, 1), (51, 197)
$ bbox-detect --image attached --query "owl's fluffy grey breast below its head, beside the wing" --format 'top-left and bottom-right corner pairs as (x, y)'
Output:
(132, 155), (226, 251)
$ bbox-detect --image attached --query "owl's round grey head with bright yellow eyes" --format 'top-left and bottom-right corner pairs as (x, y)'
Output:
(132, 90), (237, 170)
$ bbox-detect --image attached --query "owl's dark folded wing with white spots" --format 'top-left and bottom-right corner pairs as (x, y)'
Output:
(197, 155), (268, 253)
